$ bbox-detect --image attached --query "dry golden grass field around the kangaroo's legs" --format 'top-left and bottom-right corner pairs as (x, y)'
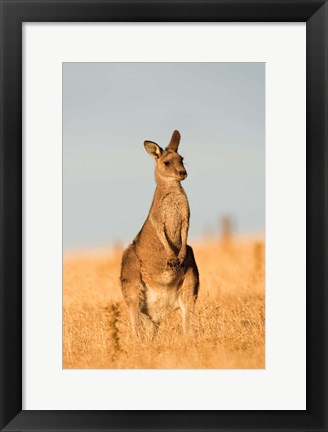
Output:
(63, 239), (265, 369)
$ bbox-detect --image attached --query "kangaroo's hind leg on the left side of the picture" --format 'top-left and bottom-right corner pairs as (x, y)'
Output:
(120, 244), (143, 336)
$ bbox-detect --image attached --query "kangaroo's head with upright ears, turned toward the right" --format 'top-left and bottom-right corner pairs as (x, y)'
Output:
(144, 130), (187, 181)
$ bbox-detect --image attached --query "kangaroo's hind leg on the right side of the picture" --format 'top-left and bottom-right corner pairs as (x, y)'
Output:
(178, 246), (199, 335)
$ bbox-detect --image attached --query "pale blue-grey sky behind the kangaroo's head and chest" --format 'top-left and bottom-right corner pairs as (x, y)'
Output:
(63, 63), (265, 250)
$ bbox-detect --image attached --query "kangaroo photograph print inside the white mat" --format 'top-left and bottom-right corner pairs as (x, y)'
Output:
(62, 63), (265, 369)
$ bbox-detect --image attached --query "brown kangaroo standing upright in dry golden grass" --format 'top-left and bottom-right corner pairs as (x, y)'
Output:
(120, 131), (199, 335)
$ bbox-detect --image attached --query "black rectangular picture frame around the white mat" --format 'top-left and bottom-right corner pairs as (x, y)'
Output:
(0, 0), (328, 432)
